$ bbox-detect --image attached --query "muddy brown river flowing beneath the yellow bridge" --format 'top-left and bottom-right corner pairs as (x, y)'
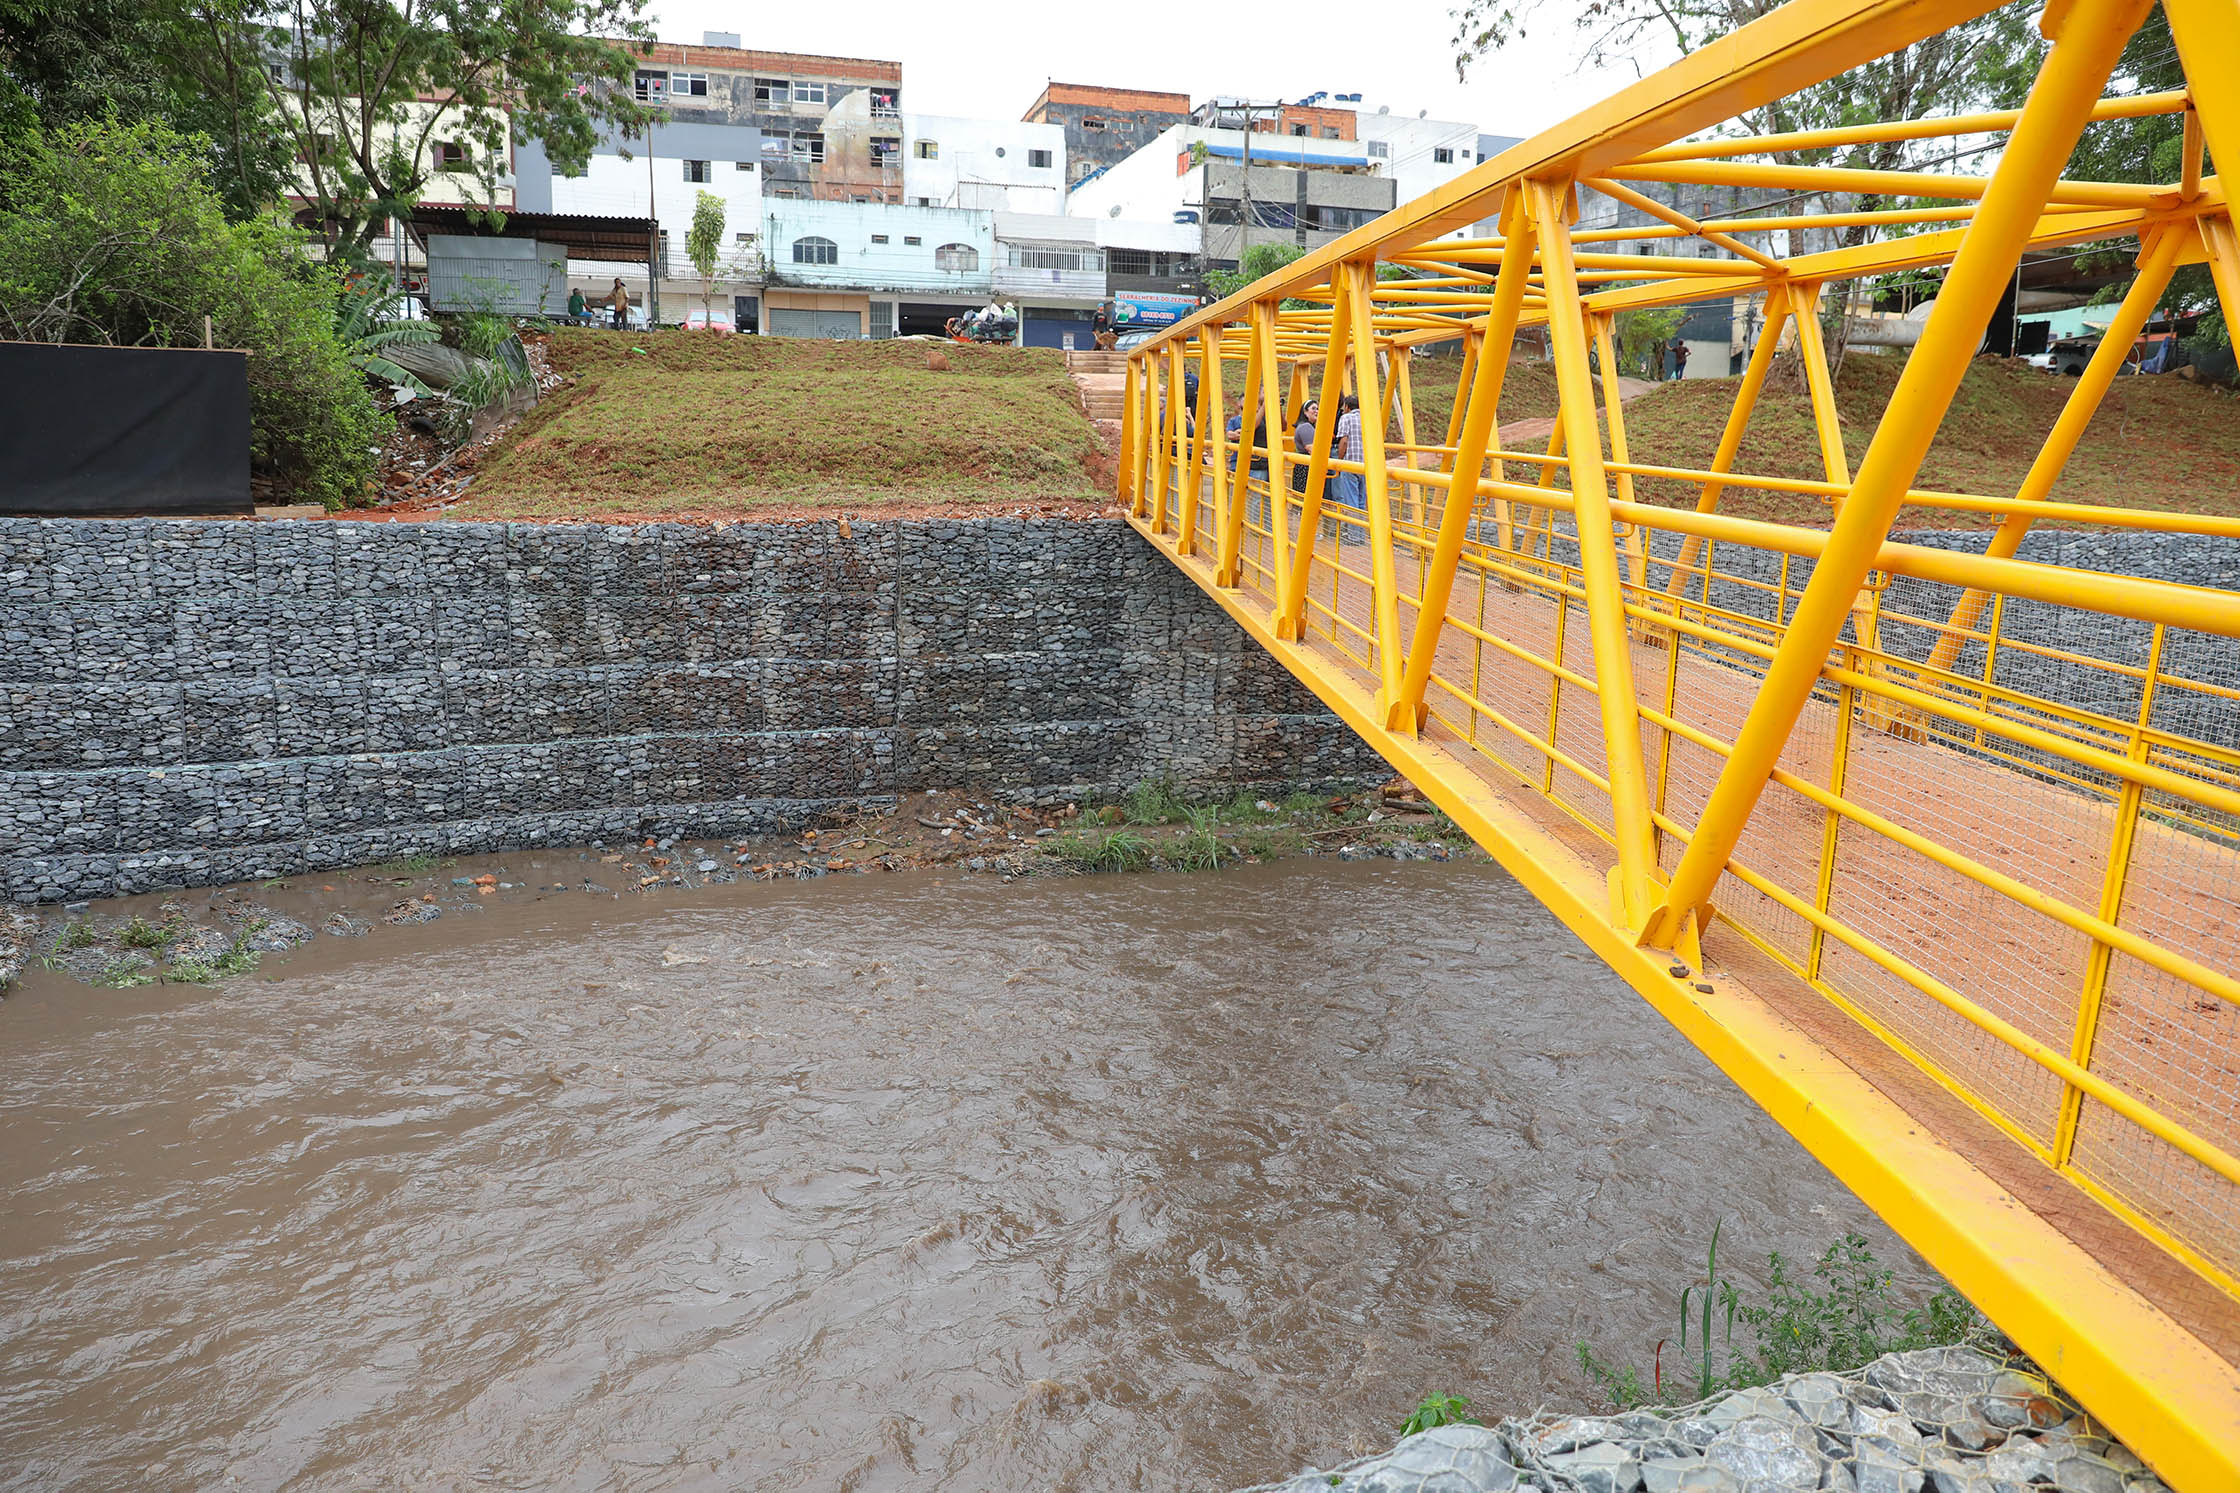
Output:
(0, 860), (1917, 1493)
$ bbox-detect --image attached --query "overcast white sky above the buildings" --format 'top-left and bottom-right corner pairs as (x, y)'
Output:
(652, 0), (1664, 134)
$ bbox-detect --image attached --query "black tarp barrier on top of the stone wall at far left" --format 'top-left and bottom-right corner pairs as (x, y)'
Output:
(0, 342), (253, 517)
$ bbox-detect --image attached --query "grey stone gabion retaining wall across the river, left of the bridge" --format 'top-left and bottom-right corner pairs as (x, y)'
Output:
(0, 519), (1384, 902)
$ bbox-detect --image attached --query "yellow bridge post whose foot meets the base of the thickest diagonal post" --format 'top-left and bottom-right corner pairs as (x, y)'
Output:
(1503, 181), (1655, 927)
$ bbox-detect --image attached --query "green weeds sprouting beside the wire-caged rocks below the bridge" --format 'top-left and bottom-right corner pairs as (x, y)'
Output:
(1579, 1227), (1994, 1410)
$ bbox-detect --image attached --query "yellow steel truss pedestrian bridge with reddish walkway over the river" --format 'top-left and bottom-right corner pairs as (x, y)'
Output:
(1120, 0), (2240, 1493)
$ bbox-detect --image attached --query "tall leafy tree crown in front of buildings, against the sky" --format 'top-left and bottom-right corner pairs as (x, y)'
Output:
(168, 0), (652, 255)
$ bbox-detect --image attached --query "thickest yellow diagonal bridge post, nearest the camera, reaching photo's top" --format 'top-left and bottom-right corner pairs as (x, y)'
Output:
(1639, 0), (2159, 949)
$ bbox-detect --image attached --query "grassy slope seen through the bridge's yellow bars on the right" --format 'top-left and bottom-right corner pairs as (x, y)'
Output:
(1413, 354), (2240, 528)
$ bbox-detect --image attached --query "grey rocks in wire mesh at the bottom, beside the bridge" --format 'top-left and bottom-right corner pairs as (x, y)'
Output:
(1243, 1348), (2168, 1493)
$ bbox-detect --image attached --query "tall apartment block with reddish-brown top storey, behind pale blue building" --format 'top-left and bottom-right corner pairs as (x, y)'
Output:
(613, 31), (903, 201)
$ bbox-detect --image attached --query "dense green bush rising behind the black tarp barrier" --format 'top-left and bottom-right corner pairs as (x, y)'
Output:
(0, 121), (388, 506)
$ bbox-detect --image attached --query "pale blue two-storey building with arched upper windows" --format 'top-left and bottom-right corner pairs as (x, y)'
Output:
(759, 197), (995, 338)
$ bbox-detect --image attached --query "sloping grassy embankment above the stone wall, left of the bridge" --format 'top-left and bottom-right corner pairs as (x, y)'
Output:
(470, 331), (1109, 519)
